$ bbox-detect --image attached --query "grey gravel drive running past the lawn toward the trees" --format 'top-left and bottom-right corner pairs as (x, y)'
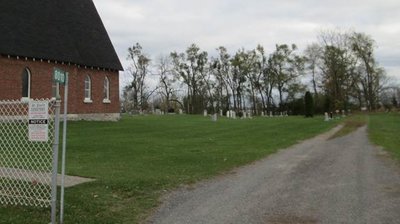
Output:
(148, 127), (400, 224)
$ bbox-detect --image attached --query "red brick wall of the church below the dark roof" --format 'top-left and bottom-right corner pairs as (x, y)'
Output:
(0, 56), (120, 114)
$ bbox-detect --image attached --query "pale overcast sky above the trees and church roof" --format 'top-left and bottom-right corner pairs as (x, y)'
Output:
(93, 0), (400, 86)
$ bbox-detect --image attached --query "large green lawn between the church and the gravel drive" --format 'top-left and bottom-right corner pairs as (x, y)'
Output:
(0, 115), (338, 224)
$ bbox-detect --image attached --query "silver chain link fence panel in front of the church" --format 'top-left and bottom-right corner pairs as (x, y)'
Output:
(0, 100), (56, 207)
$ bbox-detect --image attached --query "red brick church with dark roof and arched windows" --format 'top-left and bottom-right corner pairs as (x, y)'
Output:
(0, 0), (122, 120)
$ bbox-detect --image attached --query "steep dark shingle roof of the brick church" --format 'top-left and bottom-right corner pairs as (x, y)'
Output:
(0, 0), (122, 70)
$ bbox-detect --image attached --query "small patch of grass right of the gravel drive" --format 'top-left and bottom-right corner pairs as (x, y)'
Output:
(368, 113), (400, 161)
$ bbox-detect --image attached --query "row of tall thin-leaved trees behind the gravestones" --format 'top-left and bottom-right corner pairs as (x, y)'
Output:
(123, 31), (399, 114)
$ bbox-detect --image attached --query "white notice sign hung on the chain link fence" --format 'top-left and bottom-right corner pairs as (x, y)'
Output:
(28, 100), (49, 142)
